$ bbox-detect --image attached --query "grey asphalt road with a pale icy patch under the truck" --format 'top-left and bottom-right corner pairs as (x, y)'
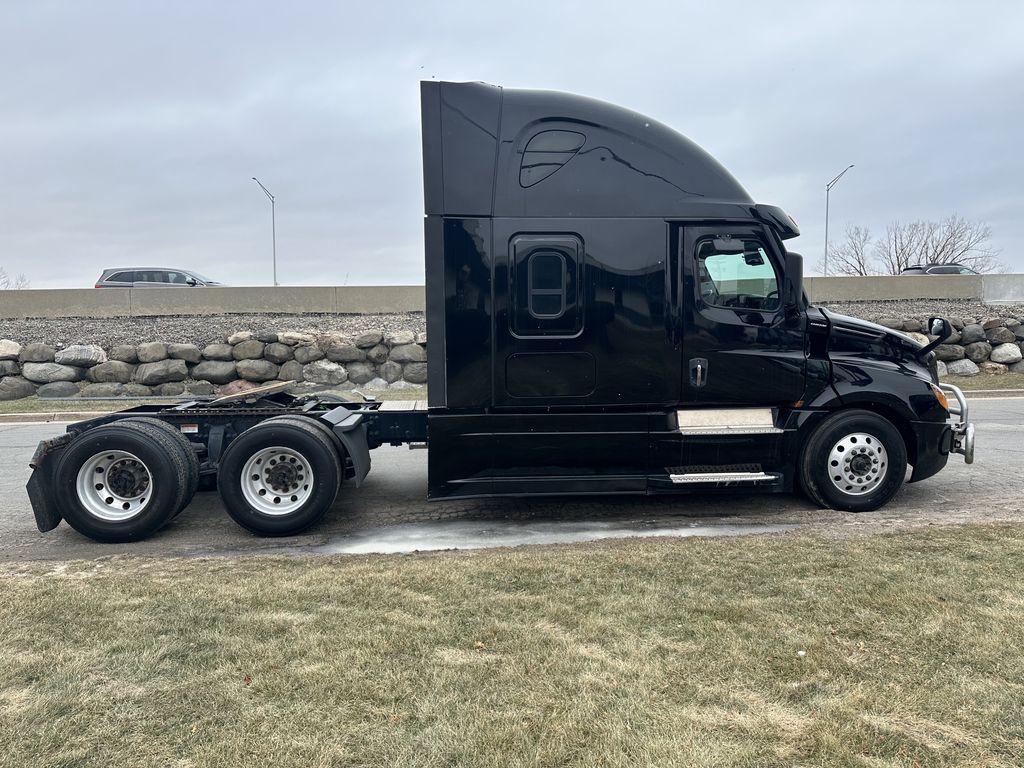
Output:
(0, 397), (1024, 561)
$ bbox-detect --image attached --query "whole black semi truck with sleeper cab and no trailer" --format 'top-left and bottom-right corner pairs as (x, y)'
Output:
(29, 82), (974, 541)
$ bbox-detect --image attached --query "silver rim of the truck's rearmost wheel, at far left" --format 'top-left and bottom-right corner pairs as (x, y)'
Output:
(75, 451), (155, 522)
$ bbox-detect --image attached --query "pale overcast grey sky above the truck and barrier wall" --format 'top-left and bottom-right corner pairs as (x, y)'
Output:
(0, 0), (1024, 288)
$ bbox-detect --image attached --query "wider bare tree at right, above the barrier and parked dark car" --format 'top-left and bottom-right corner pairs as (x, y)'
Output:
(873, 214), (1005, 274)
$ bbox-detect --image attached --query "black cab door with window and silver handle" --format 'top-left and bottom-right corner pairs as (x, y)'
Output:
(679, 225), (806, 408)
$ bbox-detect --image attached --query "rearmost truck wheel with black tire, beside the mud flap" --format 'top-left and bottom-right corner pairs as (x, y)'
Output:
(54, 421), (188, 543)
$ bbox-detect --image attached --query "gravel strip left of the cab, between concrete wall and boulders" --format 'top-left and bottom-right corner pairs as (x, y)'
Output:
(0, 312), (427, 349)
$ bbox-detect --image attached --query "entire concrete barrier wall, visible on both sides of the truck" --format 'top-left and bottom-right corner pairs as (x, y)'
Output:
(0, 274), (1024, 319)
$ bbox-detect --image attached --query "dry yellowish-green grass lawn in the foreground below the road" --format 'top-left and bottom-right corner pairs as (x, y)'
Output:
(0, 526), (1024, 768)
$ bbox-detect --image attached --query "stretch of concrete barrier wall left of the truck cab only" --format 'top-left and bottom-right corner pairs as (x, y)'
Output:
(0, 286), (426, 319)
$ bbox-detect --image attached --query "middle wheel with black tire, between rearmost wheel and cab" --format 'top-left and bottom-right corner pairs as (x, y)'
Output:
(217, 419), (342, 537)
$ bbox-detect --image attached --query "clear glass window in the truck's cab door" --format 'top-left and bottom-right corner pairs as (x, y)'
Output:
(697, 239), (779, 311)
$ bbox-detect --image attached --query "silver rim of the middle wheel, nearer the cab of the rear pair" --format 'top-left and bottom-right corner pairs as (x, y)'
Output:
(242, 445), (313, 517)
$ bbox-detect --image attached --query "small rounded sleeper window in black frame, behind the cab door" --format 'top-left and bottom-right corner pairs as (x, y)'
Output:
(509, 234), (583, 337)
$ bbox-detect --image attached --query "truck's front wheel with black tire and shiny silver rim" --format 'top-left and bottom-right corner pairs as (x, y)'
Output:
(800, 410), (907, 512)
